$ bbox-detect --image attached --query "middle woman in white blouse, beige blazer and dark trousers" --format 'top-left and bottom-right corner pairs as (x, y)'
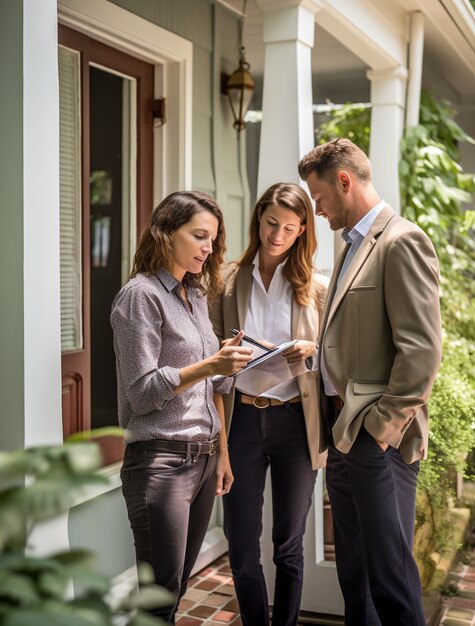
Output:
(211, 183), (328, 626)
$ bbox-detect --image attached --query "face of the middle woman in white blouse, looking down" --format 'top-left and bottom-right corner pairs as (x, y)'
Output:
(259, 204), (305, 259)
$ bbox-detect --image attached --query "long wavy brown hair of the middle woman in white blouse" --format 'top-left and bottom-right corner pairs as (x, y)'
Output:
(237, 183), (317, 306)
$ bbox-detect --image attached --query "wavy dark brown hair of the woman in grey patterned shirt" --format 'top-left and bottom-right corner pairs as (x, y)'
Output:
(130, 191), (226, 300)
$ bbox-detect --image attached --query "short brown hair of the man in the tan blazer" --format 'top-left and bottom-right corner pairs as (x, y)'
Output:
(298, 137), (371, 183)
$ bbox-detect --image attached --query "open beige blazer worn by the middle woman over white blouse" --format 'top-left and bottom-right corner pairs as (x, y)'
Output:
(210, 263), (328, 469)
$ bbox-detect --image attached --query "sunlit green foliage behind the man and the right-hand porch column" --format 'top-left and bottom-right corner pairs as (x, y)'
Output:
(317, 92), (475, 584)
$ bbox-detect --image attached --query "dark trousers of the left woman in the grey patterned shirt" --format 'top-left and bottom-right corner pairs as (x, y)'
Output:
(121, 444), (217, 624)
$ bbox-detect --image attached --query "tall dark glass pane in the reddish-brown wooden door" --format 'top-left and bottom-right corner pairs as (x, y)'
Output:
(89, 64), (136, 428)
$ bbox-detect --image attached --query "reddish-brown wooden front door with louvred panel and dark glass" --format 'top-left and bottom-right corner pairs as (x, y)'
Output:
(59, 25), (153, 464)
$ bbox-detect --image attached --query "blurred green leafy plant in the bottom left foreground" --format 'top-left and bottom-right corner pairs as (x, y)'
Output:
(0, 443), (173, 626)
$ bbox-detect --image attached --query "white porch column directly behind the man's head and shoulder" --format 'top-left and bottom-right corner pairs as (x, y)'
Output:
(367, 66), (407, 212)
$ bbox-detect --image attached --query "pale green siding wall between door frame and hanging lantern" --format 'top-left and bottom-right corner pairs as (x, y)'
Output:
(108, 0), (250, 259)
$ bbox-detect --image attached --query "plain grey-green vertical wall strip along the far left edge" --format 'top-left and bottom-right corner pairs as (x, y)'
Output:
(0, 1), (25, 450)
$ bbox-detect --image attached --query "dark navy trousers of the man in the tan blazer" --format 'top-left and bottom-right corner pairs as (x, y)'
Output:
(326, 427), (426, 626)
